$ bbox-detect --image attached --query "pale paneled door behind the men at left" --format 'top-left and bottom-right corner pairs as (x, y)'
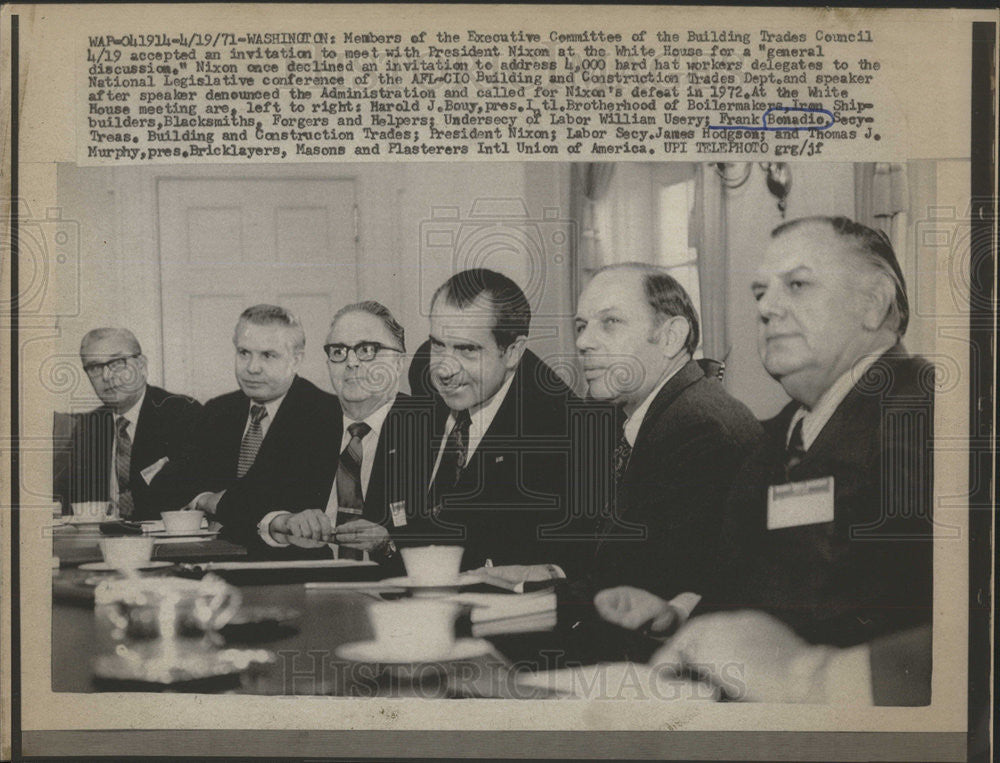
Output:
(157, 178), (359, 401)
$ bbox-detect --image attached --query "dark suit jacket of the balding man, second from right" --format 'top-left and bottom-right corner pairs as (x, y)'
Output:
(590, 361), (763, 597)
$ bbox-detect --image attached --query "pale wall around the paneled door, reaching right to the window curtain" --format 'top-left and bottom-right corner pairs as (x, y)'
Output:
(53, 162), (574, 410)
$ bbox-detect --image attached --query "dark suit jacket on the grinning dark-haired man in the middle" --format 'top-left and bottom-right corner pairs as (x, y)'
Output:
(396, 351), (579, 569)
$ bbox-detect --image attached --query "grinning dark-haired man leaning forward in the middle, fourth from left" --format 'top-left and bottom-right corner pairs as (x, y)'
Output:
(406, 269), (575, 569)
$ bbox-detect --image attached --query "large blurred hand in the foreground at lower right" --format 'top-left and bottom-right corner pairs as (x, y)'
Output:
(652, 612), (833, 702)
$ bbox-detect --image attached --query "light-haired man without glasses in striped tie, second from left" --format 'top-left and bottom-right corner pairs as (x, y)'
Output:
(186, 305), (342, 545)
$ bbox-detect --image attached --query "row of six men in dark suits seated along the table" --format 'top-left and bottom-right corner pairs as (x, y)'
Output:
(55, 217), (933, 704)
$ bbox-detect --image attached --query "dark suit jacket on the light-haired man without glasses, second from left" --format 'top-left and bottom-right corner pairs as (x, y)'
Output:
(185, 376), (343, 550)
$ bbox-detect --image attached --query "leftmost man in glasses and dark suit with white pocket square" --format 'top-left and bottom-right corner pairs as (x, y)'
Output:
(53, 328), (201, 521)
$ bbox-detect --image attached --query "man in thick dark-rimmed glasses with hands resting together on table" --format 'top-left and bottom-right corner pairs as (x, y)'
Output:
(259, 301), (430, 562)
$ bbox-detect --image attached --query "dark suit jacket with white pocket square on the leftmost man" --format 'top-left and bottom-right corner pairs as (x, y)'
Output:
(53, 385), (201, 520)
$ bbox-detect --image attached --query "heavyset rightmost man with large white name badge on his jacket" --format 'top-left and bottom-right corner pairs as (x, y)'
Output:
(604, 217), (934, 701)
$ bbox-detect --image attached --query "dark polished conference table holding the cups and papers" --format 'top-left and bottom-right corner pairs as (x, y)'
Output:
(52, 526), (592, 698)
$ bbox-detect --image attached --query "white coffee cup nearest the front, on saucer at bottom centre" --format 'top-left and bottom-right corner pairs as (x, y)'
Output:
(368, 599), (459, 661)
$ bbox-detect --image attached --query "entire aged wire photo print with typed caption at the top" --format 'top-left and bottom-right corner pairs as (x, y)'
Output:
(3, 5), (996, 760)
